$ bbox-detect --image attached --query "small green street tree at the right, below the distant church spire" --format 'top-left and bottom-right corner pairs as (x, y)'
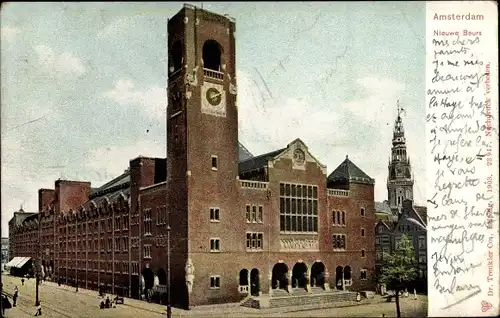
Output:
(380, 234), (417, 318)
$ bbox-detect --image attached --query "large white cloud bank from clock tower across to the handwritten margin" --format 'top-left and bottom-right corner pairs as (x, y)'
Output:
(237, 71), (425, 204)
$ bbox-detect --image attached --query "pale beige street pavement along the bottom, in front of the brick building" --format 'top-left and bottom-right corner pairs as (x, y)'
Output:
(2, 275), (427, 318)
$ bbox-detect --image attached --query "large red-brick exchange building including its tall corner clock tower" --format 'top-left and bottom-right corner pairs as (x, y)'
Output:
(9, 5), (376, 308)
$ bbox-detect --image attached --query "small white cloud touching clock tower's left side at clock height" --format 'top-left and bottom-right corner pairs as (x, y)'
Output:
(104, 80), (167, 120)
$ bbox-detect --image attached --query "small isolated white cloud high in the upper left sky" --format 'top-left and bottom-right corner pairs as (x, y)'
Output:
(35, 45), (86, 76)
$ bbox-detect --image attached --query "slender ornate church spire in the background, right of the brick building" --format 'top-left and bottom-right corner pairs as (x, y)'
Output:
(387, 101), (413, 214)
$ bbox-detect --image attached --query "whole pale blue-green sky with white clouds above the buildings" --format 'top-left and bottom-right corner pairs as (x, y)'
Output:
(1, 1), (426, 236)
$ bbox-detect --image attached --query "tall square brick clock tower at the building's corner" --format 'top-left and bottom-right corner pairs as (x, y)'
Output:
(167, 4), (239, 306)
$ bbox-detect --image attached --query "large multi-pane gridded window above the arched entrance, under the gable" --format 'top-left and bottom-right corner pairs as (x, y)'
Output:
(280, 183), (318, 233)
